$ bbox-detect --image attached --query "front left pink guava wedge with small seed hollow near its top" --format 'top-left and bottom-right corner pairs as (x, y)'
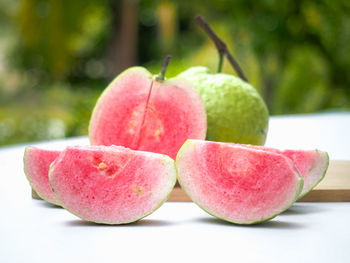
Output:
(49, 146), (176, 224)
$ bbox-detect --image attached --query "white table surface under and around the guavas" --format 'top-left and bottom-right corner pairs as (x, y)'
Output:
(0, 113), (350, 263)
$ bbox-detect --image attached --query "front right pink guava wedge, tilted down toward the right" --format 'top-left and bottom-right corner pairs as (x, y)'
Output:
(176, 140), (303, 224)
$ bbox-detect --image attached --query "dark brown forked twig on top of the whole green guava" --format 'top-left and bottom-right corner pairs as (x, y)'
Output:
(195, 15), (249, 82)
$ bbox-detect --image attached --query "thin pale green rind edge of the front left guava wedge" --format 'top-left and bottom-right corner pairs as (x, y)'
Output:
(49, 156), (177, 225)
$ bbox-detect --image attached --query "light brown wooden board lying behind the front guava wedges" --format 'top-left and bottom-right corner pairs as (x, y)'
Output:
(32, 161), (350, 202)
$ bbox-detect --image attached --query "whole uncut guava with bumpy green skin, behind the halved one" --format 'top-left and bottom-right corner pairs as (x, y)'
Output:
(178, 67), (269, 145)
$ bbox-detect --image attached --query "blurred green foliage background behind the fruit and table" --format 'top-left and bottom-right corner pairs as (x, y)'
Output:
(0, 0), (350, 145)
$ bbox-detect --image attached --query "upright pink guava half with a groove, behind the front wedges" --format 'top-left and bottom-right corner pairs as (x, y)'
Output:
(89, 67), (206, 158)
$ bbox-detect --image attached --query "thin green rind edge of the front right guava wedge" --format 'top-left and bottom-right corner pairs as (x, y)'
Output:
(175, 140), (304, 225)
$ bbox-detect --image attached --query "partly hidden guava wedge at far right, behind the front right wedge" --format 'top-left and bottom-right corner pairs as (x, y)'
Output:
(238, 145), (329, 198)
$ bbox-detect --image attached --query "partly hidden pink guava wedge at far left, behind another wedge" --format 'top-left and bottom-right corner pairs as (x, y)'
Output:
(23, 147), (60, 205)
